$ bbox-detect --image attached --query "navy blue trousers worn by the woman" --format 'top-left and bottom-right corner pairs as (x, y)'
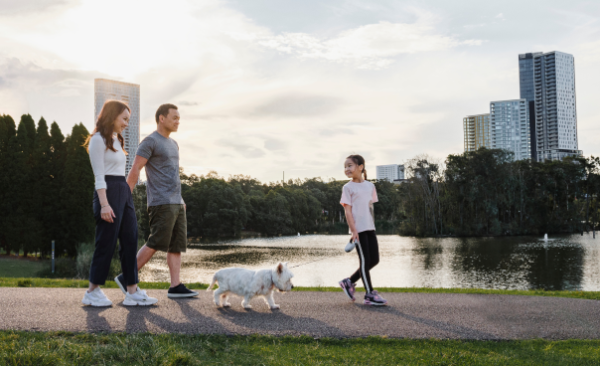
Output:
(90, 175), (139, 286)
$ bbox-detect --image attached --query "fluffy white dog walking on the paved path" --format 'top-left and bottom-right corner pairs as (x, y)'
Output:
(207, 262), (294, 309)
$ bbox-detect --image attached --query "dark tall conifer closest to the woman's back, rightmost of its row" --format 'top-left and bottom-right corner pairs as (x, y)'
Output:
(57, 124), (94, 256)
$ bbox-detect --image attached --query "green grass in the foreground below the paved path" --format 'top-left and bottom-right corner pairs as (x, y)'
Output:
(0, 331), (600, 366)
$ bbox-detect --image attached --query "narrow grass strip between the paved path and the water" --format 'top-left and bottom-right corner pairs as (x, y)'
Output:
(0, 277), (600, 300)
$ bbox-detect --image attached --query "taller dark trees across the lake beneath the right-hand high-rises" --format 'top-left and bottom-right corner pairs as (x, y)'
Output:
(399, 148), (600, 236)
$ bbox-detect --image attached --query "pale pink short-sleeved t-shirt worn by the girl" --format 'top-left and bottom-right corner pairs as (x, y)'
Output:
(340, 180), (379, 233)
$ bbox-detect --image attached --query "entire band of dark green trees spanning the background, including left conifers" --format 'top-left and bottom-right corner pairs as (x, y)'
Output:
(0, 114), (600, 257)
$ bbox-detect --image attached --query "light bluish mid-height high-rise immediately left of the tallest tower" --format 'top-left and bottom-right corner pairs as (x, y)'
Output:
(490, 99), (531, 160)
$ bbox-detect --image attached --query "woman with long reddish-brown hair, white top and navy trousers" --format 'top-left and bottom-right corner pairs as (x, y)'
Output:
(82, 100), (158, 306)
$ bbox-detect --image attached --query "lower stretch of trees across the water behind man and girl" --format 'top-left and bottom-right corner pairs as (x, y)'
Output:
(134, 169), (400, 240)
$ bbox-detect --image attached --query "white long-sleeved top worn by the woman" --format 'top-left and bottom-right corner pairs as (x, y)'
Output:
(89, 132), (127, 190)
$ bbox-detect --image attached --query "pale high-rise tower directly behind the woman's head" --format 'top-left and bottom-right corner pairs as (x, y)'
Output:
(94, 79), (140, 176)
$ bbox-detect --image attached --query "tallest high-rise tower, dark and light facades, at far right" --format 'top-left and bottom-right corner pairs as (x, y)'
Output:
(519, 51), (581, 161)
